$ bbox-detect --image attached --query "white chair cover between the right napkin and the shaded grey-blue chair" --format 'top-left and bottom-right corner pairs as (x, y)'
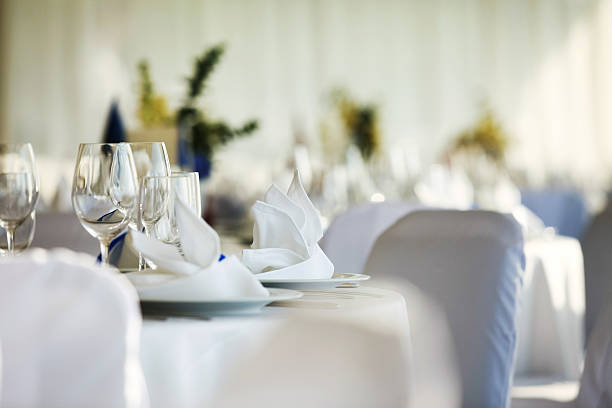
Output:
(319, 202), (423, 273)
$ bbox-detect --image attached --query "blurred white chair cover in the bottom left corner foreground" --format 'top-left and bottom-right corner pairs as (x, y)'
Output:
(0, 249), (147, 408)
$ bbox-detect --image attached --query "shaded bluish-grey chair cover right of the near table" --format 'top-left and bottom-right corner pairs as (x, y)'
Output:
(365, 210), (525, 407)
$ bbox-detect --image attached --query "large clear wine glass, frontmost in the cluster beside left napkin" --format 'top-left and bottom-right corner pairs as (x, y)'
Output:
(72, 143), (138, 264)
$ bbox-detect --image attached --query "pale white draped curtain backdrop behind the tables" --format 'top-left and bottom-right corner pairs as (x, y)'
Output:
(0, 0), (612, 188)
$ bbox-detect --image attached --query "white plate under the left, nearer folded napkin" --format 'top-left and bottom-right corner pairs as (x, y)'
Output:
(140, 289), (302, 317)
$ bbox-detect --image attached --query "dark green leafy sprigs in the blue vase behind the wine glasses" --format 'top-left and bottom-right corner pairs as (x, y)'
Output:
(177, 44), (258, 159)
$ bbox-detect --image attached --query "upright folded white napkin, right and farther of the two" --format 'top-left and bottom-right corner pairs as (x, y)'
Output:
(242, 170), (334, 279)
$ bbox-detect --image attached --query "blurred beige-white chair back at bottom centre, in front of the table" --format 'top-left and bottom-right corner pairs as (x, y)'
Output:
(210, 318), (408, 408)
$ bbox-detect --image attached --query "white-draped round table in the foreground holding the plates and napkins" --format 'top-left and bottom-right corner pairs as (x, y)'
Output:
(141, 286), (408, 407)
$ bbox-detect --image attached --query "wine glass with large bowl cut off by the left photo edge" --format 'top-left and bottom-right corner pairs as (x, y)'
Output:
(0, 143), (39, 254)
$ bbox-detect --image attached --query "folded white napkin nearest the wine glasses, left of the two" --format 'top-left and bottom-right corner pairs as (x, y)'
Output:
(127, 200), (269, 301)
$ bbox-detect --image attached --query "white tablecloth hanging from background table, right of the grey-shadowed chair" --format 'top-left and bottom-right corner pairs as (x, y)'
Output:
(515, 236), (585, 380)
